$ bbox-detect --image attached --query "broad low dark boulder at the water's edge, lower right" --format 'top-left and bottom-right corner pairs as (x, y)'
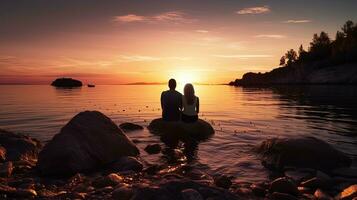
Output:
(255, 136), (352, 171)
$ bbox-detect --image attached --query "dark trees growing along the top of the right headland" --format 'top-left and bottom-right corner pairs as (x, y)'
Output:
(280, 20), (357, 66)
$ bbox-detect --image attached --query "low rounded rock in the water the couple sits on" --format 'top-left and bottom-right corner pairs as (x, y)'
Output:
(148, 118), (214, 140)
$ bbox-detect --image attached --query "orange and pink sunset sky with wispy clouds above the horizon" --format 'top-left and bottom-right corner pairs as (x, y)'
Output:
(0, 0), (357, 84)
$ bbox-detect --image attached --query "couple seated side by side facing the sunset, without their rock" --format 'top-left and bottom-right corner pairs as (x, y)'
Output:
(161, 79), (199, 123)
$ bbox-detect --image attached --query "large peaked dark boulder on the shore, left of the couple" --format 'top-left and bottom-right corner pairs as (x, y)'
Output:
(37, 111), (139, 175)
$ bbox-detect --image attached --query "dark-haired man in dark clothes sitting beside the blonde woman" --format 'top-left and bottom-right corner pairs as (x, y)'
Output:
(161, 79), (182, 121)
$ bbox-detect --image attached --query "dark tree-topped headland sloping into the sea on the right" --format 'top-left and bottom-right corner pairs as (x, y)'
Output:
(229, 21), (357, 86)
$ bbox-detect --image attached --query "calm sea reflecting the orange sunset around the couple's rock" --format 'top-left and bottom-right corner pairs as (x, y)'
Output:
(0, 85), (357, 181)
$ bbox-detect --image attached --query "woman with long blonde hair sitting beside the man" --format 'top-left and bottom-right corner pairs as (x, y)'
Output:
(182, 83), (200, 123)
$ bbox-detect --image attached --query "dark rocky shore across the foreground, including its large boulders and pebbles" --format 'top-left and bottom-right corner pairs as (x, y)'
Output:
(0, 111), (357, 200)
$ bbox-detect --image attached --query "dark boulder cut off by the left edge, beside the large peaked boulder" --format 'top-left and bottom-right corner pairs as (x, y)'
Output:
(0, 129), (41, 161)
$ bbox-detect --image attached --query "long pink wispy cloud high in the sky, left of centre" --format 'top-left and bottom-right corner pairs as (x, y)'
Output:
(113, 11), (195, 23)
